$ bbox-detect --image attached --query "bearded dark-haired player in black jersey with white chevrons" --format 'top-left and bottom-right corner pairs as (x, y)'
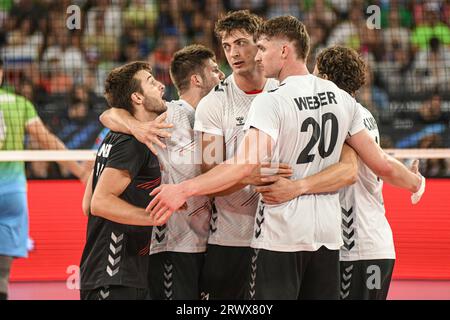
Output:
(80, 62), (169, 300)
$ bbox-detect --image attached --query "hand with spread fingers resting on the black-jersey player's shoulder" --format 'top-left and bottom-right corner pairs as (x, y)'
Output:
(131, 112), (173, 155)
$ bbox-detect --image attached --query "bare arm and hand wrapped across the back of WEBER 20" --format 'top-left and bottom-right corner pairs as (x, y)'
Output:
(255, 144), (358, 204)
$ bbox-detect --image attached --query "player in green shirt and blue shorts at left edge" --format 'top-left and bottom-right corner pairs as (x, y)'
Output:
(0, 59), (86, 300)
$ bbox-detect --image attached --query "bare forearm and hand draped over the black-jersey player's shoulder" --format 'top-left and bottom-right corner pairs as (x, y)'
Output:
(100, 108), (173, 155)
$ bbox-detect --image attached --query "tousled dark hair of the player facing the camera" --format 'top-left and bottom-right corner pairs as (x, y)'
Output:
(214, 10), (263, 39)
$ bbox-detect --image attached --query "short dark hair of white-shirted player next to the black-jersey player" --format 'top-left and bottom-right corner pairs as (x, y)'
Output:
(170, 44), (215, 93)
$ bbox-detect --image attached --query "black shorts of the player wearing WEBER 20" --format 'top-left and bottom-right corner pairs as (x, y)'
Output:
(247, 247), (339, 300)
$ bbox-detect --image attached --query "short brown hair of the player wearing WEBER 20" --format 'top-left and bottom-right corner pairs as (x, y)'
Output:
(256, 16), (310, 62)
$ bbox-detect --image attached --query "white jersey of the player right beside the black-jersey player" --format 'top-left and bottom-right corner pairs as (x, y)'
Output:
(150, 100), (211, 254)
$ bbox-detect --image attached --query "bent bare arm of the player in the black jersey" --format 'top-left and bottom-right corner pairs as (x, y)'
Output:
(91, 168), (170, 226)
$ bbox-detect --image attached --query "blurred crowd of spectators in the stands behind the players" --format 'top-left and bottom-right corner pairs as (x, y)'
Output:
(0, 0), (450, 178)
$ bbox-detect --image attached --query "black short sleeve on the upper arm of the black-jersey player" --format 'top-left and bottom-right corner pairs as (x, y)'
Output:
(105, 137), (150, 179)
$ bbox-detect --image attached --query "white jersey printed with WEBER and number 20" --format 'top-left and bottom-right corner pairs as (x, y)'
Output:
(245, 75), (364, 252)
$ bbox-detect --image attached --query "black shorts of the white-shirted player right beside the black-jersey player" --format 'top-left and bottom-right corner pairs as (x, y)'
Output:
(148, 252), (205, 300)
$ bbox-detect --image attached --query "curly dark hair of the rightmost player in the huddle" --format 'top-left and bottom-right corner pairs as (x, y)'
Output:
(316, 46), (366, 94)
